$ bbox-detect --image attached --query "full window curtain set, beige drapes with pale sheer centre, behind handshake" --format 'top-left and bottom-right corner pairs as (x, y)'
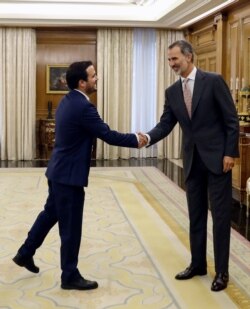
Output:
(97, 29), (184, 159)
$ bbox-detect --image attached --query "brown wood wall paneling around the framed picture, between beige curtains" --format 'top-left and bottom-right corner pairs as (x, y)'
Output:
(36, 29), (97, 158)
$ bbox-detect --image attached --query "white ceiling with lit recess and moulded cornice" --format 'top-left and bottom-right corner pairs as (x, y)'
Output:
(0, 0), (239, 29)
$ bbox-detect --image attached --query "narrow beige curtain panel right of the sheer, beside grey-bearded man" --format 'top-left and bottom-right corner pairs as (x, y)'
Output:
(156, 30), (184, 159)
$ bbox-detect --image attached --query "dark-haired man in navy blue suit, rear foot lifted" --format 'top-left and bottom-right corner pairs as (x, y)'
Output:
(13, 61), (141, 290)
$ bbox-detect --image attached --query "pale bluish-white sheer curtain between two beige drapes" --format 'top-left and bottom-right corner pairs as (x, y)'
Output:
(130, 29), (157, 158)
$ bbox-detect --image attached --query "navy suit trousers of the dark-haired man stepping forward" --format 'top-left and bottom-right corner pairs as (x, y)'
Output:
(18, 181), (85, 282)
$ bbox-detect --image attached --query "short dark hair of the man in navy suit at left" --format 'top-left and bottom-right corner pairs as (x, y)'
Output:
(66, 61), (93, 90)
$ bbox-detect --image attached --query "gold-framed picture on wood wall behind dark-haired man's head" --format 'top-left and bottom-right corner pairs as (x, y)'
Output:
(46, 64), (69, 94)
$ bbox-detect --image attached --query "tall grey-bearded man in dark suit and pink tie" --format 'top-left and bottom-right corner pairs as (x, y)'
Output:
(140, 40), (239, 291)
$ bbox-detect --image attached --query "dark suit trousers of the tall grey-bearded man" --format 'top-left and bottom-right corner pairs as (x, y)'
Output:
(186, 149), (232, 273)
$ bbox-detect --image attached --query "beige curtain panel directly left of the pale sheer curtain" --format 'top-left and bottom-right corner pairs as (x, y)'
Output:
(96, 29), (133, 160)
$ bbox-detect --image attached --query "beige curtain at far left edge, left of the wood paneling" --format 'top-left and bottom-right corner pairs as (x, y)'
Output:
(0, 28), (36, 160)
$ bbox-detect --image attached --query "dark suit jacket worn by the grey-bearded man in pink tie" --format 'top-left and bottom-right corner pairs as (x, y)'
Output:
(148, 69), (239, 178)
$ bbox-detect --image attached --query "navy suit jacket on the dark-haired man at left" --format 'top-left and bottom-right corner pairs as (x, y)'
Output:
(46, 90), (138, 186)
